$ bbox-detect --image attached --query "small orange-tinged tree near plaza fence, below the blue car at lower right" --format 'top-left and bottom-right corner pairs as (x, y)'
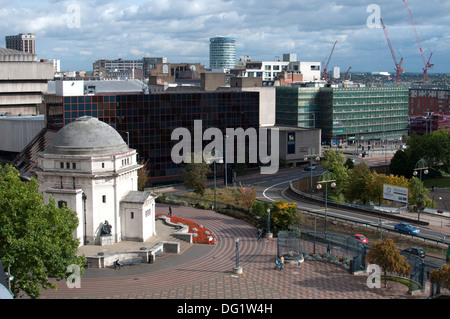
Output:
(366, 239), (412, 288)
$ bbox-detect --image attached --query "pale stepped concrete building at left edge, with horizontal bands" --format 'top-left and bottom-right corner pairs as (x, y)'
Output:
(0, 48), (54, 115)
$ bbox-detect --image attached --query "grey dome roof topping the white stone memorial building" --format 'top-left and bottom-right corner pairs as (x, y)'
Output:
(45, 116), (129, 155)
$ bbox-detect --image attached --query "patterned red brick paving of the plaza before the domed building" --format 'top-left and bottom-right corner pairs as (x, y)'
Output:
(41, 205), (428, 299)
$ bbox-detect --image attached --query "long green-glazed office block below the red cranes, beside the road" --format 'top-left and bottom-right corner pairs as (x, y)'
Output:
(276, 87), (408, 142)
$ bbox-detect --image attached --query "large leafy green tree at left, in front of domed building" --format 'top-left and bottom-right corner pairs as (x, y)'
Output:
(0, 165), (86, 298)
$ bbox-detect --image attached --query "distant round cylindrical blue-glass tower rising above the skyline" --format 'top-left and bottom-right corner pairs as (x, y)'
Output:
(209, 37), (236, 70)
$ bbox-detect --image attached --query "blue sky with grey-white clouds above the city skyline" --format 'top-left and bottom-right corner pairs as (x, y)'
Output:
(0, 0), (450, 73)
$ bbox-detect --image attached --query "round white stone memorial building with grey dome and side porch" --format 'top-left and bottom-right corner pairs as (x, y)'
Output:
(36, 116), (156, 245)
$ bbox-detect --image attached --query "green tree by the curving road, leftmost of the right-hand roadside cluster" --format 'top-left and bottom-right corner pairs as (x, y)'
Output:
(322, 149), (348, 193)
